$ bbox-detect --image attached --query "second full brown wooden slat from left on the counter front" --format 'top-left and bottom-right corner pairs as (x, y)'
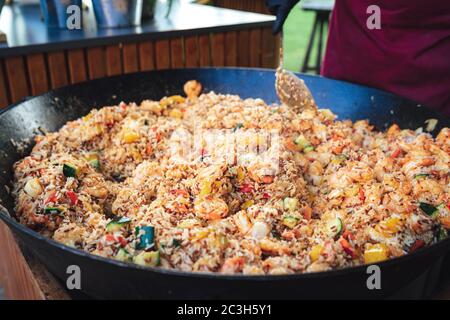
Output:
(26, 53), (49, 96)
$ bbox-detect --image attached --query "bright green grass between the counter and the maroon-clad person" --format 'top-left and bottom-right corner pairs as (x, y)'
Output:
(284, 6), (326, 71)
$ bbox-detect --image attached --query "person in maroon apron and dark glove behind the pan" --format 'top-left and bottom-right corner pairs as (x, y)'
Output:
(266, 0), (450, 116)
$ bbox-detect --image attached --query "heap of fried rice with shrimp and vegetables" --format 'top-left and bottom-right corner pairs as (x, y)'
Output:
(13, 81), (450, 275)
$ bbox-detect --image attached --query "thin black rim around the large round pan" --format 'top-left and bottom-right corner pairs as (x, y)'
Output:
(0, 67), (450, 281)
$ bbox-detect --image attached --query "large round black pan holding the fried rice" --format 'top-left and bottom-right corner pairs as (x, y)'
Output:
(0, 69), (450, 299)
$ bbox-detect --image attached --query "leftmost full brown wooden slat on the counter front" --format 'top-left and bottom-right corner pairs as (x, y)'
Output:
(5, 57), (30, 103)
